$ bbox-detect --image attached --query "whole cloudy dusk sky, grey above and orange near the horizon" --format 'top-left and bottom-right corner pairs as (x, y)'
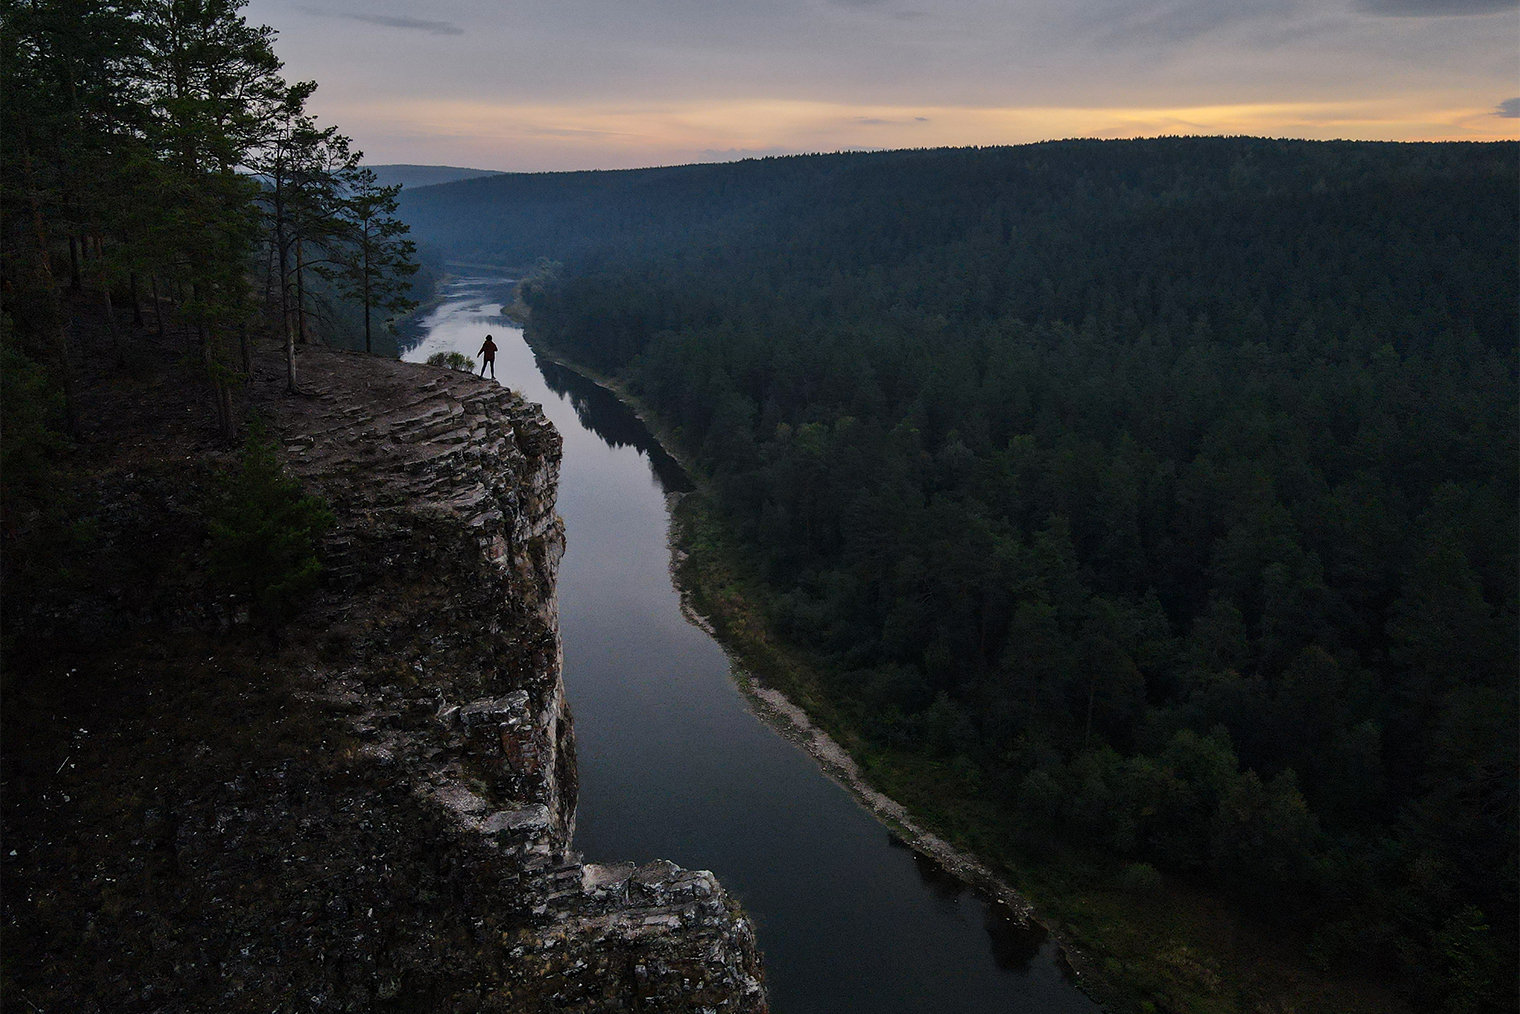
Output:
(245, 0), (1520, 172)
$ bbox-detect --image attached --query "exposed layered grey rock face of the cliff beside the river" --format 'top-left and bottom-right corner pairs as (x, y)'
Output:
(260, 351), (765, 1011)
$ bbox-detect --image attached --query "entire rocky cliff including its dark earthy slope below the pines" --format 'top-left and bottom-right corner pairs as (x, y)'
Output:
(0, 339), (765, 1011)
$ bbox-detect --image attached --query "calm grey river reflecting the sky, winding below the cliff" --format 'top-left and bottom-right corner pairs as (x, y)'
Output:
(404, 278), (1097, 1014)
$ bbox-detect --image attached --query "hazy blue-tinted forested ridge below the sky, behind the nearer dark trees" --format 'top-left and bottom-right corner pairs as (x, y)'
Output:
(400, 137), (1517, 355)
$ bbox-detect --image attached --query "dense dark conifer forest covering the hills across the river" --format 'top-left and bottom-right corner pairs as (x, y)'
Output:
(403, 138), (1520, 1011)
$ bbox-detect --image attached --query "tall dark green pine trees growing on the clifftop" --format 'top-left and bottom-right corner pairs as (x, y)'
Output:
(0, 0), (430, 425)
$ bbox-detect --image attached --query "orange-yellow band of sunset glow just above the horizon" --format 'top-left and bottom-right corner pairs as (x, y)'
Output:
(328, 94), (1520, 170)
